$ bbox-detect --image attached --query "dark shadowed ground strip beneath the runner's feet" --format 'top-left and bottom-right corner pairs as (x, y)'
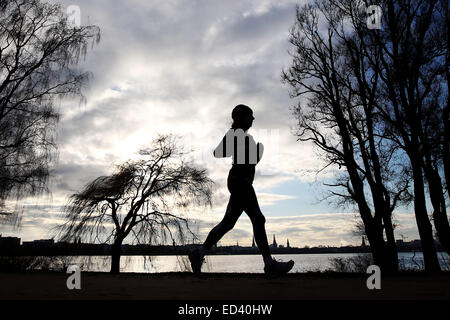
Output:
(0, 272), (450, 300)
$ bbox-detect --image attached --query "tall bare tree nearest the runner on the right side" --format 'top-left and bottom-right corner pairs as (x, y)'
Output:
(282, 1), (409, 272)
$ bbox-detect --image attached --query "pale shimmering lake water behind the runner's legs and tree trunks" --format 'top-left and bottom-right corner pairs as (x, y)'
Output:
(62, 252), (450, 273)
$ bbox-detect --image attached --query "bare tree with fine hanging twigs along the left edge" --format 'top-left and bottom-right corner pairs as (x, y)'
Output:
(0, 0), (100, 219)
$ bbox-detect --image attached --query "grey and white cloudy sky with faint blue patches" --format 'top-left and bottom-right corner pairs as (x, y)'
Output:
(0, 0), (418, 247)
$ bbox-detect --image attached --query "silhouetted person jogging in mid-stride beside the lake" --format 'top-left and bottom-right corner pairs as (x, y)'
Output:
(189, 104), (294, 277)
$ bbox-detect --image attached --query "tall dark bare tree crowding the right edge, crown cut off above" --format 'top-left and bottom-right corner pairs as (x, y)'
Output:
(356, 0), (450, 272)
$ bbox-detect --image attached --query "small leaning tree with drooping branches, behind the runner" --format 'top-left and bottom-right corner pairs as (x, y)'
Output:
(59, 135), (213, 273)
